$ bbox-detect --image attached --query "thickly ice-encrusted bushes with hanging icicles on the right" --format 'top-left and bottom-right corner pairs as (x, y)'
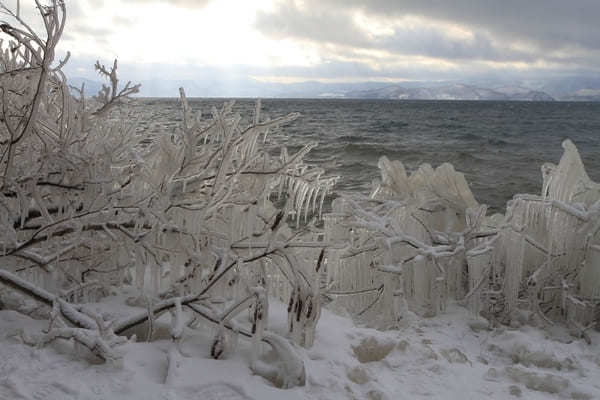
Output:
(325, 140), (600, 336)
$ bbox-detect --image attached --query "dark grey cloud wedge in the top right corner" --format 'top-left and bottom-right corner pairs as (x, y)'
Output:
(340, 0), (600, 49)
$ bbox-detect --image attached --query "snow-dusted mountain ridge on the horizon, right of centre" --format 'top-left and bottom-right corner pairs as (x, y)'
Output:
(346, 84), (554, 101)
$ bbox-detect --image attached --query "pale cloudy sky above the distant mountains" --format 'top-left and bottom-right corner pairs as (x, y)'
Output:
(7, 0), (600, 95)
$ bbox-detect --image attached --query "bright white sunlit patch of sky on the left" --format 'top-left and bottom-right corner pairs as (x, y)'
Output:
(63, 0), (319, 67)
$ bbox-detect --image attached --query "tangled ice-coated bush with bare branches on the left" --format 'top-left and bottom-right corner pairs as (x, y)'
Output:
(0, 0), (336, 386)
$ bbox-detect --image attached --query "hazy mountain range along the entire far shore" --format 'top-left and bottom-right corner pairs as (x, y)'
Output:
(69, 77), (600, 101)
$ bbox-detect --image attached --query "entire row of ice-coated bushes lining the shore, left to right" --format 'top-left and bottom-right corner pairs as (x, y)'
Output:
(0, 0), (600, 387)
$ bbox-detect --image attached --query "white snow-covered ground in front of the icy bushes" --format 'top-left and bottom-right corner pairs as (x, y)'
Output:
(0, 290), (600, 400)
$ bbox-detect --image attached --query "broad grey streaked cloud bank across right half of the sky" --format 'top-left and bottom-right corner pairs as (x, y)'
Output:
(256, 0), (600, 67)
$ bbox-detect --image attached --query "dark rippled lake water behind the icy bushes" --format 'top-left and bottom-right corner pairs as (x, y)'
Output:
(132, 99), (600, 211)
